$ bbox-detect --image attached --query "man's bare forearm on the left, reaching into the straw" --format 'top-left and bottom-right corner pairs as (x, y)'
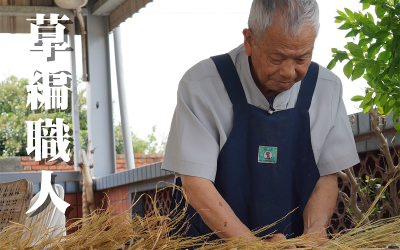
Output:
(181, 175), (254, 239)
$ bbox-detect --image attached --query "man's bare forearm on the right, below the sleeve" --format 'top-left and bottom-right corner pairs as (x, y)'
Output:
(303, 174), (338, 234)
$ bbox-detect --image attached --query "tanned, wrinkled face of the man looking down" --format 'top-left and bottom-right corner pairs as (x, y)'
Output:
(243, 19), (315, 96)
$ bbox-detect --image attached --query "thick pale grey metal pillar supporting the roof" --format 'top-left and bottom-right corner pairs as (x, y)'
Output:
(86, 0), (116, 177)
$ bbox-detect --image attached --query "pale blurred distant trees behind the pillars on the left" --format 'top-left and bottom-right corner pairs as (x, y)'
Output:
(0, 76), (166, 157)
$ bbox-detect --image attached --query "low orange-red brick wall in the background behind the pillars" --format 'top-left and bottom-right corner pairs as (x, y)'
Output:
(21, 154), (164, 172)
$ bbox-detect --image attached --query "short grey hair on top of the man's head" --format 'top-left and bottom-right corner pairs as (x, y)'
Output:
(248, 0), (319, 40)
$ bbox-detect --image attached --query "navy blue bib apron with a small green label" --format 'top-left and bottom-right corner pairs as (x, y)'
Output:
(170, 54), (320, 244)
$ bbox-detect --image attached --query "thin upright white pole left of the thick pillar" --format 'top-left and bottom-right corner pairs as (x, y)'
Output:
(68, 15), (81, 171)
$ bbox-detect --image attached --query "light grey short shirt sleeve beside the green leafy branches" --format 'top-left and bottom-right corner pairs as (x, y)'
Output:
(317, 78), (360, 176)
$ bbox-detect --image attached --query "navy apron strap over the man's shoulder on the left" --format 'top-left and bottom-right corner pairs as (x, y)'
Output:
(211, 54), (247, 108)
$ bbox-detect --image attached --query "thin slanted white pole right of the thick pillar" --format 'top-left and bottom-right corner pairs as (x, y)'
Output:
(114, 26), (135, 170)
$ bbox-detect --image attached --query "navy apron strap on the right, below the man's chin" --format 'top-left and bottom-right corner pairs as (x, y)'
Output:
(296, 62), (319, 110)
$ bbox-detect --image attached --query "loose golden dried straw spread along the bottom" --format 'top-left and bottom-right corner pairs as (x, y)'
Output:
(0, 185), (400, 250)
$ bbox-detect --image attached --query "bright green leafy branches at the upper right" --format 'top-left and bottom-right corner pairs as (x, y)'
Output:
(327, 0), (400, 138)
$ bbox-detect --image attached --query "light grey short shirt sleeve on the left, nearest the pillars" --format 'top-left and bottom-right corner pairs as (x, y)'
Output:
(162, 76), (219, 182)
